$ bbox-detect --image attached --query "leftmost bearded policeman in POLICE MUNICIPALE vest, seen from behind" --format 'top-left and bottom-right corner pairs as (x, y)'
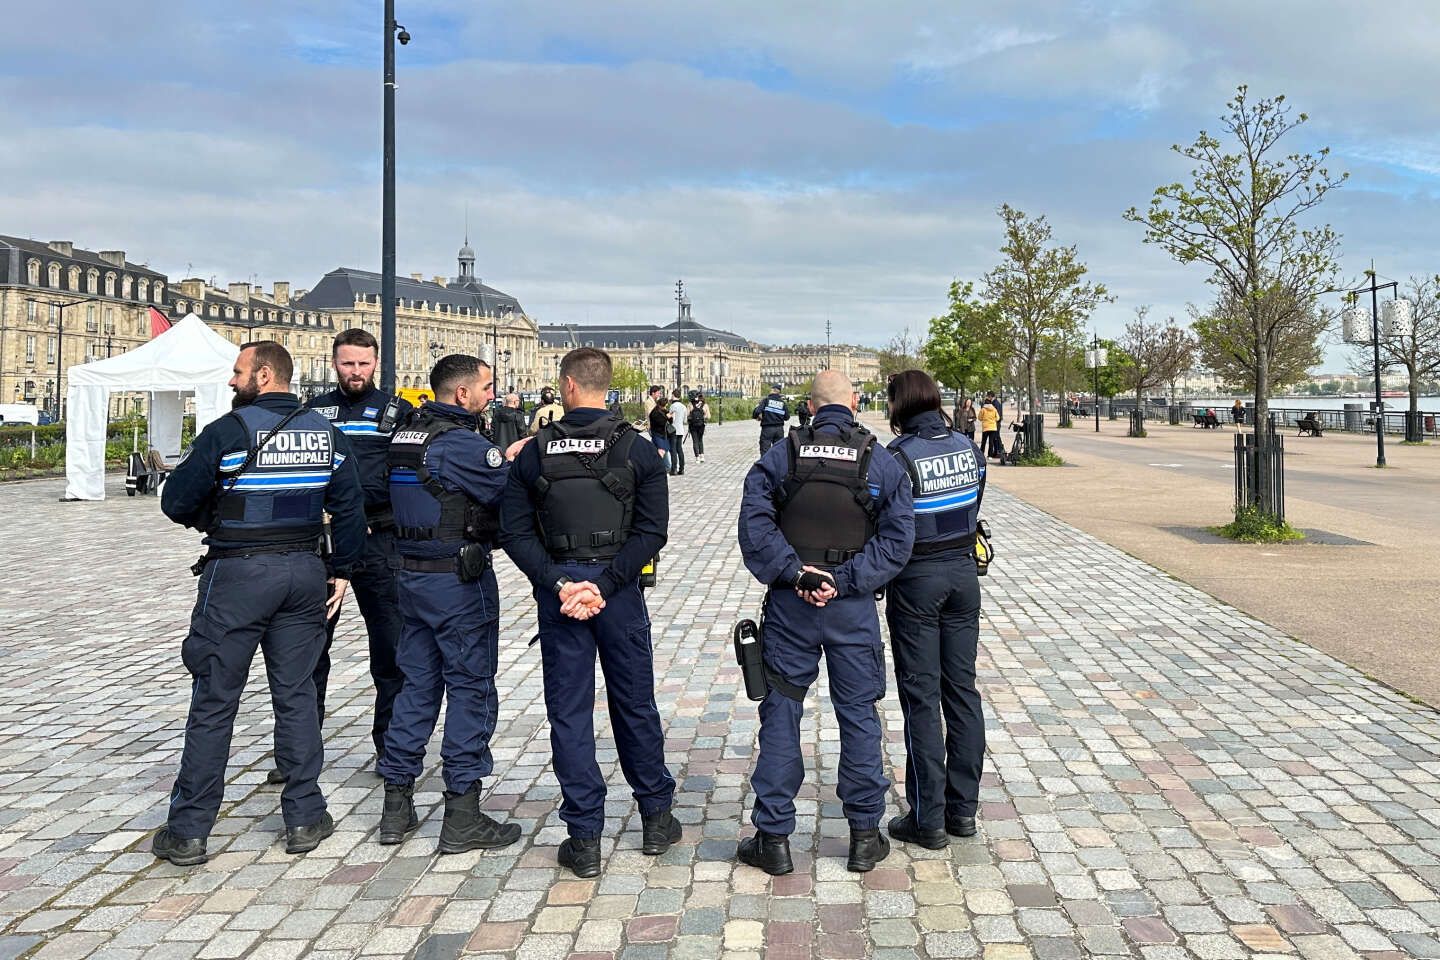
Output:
(151, 340), (364, 866)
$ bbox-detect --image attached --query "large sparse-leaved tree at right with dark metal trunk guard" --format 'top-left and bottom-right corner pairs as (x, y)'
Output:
(1125, 86), (1346, 512)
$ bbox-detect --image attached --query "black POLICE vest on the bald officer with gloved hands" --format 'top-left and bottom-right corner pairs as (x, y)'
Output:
(775, 425), (876, 570)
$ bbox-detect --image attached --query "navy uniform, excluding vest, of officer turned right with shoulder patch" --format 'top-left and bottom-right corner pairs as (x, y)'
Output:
(377, 400), (510, 793)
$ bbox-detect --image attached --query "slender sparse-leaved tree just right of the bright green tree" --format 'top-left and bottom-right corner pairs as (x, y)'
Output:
(984, 203), (1110, 410)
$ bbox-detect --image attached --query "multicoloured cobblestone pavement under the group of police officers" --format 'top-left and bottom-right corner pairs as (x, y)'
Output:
(0, 423), (1440, 960)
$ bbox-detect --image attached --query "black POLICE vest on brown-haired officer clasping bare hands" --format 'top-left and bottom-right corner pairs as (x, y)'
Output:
(536, 416), (635, 560)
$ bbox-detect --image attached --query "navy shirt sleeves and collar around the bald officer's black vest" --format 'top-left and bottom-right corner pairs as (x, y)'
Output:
(740, 403), (914, 597)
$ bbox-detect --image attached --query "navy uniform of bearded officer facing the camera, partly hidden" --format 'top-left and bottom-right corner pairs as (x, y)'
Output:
(305, 387), (415, 754)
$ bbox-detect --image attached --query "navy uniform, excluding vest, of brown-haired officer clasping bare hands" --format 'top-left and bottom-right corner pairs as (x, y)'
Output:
(500, 407), (675, 838)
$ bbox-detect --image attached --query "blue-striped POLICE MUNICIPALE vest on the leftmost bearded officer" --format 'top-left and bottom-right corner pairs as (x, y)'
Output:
(207, 404), (344, 543)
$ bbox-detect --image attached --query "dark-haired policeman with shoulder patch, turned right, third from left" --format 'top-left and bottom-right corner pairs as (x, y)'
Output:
(380, 354), (520, 853)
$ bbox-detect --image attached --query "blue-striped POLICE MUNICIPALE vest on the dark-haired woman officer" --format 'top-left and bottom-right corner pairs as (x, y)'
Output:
(890, 417), (985, 557)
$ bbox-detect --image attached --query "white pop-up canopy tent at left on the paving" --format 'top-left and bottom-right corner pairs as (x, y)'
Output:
(65, 314), (239, 499)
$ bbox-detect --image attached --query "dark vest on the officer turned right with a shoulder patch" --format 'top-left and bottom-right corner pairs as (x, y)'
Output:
(386, 413), (498, 548)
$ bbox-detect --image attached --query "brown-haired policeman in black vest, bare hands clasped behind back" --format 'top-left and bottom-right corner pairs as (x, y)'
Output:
(501, 347), (681, 877)
